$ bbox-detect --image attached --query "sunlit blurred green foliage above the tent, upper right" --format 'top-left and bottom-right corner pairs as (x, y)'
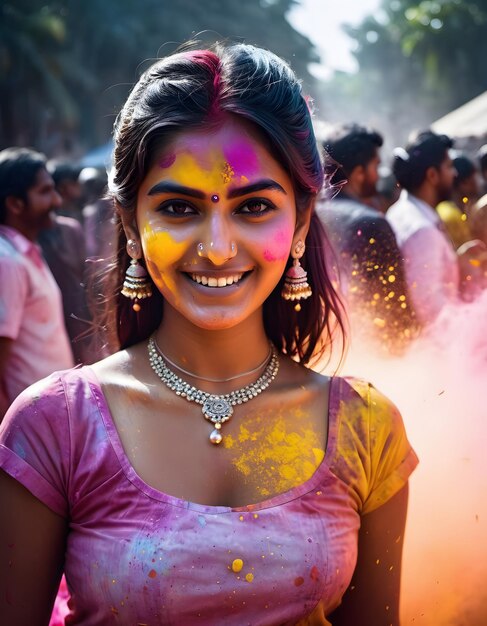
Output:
(318, 0), (487, 144)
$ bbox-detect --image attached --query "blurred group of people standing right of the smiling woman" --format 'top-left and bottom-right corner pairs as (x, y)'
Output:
(317, 124), (487, 355)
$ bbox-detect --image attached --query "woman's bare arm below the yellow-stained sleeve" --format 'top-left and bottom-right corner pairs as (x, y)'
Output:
(329, 484), (408, 626)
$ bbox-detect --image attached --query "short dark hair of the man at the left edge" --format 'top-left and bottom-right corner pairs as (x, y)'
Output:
(0, 148), (46, 224)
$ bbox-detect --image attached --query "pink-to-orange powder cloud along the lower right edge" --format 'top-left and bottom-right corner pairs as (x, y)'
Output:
(330, 292), (487, 626)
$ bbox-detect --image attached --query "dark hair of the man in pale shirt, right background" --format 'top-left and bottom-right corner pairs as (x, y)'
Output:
(392, 130), (453, 192)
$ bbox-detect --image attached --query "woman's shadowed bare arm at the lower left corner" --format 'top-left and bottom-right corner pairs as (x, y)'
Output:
(0, 470), (67, 626)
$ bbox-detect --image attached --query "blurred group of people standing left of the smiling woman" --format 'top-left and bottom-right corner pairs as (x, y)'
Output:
(0, 148), (115, 419)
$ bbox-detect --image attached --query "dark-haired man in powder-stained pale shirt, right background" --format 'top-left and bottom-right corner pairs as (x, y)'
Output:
(386, 131), (459, 325)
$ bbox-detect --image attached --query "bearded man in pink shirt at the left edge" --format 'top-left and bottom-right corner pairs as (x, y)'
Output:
(0, 148), (73, 419)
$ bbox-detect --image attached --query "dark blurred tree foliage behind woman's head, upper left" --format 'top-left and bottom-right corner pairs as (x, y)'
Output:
(0, 0), (318, 152)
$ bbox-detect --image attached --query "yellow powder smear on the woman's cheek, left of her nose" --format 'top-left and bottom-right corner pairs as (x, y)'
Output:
(142, 223), (188, 292)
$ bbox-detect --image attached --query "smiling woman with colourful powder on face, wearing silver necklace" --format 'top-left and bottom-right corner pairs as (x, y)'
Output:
(0, 44), (417, 626)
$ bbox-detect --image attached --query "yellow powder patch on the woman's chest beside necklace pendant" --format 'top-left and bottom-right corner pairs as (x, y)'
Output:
(224, 416), (325, 496)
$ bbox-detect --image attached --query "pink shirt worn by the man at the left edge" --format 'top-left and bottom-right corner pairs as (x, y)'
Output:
(0, 225), (74, 402)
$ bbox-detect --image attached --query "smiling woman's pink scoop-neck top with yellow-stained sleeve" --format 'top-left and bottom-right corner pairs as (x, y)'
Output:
(0, 367), (417, 626)
